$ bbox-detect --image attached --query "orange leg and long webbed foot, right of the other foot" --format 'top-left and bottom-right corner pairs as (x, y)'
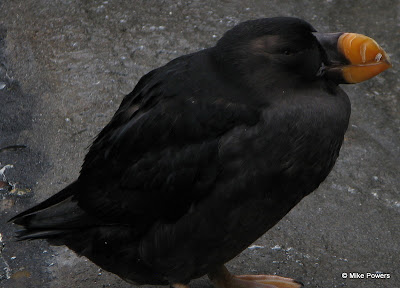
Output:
(208, 265), (303, 288)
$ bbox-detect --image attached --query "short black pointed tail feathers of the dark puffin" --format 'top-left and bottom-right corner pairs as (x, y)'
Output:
(9, 182), (97, 240)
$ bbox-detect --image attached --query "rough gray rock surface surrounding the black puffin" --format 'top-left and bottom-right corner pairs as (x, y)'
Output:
(0, 0), (400, 288)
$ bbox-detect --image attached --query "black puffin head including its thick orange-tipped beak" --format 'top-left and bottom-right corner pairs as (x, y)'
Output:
(215, 17), (391, 87)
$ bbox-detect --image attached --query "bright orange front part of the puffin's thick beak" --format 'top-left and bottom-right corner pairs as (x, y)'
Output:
(338, 33), (392, 83)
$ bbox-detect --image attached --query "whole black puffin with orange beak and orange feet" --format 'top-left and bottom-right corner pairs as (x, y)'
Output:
(11, 17), (390, 288)
